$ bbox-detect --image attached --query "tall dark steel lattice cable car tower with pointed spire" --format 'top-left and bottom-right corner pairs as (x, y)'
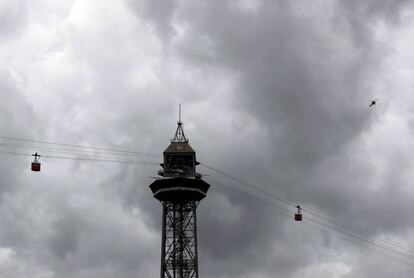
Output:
(150, 107), (210, 278)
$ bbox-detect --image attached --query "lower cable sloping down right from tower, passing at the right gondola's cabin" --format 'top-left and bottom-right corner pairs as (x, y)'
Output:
(206, 179), (414, 267)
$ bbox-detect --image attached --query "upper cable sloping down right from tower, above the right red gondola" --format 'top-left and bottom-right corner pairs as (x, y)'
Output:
(201, 163), (414, 256)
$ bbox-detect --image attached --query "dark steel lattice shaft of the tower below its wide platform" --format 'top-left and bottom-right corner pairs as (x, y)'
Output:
(161, 201), (198, 278)
